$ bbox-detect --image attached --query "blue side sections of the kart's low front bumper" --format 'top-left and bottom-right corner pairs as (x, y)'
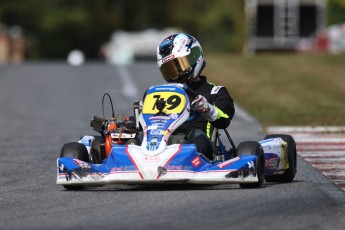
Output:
(58, 144), (257, 183)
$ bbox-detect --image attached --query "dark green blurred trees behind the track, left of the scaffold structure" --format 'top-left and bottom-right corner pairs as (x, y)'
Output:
(0, 0), (253, 58)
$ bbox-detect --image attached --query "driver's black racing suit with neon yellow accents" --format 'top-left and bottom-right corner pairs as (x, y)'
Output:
(177, 76), (235, 160)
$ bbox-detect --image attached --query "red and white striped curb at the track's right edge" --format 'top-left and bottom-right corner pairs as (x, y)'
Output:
(267, 126), (345, 191)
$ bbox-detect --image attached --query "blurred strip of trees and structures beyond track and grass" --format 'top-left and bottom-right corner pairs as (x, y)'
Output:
(0, 0), (345, 63)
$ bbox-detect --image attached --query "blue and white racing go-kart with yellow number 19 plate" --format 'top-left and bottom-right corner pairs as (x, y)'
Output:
(56, 84), (296, 190)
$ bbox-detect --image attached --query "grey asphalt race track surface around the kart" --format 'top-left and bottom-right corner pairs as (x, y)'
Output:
(0, 62), (345, 230)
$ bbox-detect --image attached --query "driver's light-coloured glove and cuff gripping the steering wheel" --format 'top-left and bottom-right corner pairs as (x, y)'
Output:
(191, 95), (218, 121)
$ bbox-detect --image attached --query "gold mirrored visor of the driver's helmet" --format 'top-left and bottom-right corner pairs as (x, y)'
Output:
(159, 56), (192, 82)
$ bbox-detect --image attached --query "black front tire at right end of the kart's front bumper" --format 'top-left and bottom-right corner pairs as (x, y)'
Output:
(237, 141), (265, 188)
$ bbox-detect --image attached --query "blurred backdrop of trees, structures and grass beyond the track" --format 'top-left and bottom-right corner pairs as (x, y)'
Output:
(0, 0), (345, 126)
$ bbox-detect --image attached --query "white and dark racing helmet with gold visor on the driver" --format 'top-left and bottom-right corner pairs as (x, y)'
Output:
(157, 33), (206, 85)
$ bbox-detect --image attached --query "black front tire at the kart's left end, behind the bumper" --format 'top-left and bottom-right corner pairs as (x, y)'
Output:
(60, 142), (89, 190)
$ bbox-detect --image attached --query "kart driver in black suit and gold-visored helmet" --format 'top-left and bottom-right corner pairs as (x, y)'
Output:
(157, 33), (235, 161)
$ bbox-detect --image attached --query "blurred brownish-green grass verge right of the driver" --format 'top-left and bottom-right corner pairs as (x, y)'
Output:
(204, 53), (345, 126)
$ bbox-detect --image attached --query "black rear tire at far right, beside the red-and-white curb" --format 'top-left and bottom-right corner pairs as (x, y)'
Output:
(265, 134), (297, 182)
